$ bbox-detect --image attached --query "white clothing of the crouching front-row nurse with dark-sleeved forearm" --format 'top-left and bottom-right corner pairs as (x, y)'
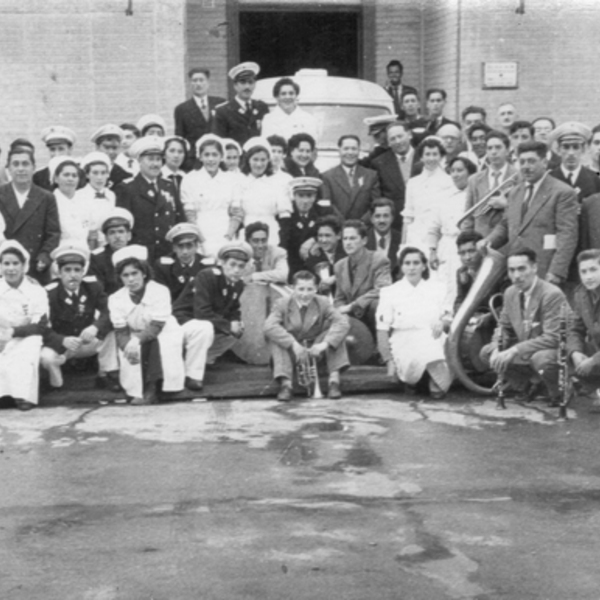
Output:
(108, 281), (185, 398)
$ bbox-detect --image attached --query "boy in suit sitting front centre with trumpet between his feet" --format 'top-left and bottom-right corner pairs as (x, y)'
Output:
(265, 271), (349, 401)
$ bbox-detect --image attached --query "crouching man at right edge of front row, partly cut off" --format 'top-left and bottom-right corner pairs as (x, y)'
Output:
(567, 249), (600, 412)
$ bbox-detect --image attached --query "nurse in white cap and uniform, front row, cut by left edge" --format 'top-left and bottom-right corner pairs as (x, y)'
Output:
(0, 240), (49, 410)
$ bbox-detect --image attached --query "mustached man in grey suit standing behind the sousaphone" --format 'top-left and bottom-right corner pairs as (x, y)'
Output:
(478, 142), (578, 285)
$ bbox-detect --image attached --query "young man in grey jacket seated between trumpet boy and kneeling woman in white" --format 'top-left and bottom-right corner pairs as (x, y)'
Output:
(334, 220), (392, 333)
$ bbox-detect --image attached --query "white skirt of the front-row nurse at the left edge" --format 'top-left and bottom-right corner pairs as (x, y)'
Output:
(0, 335), (42, 404)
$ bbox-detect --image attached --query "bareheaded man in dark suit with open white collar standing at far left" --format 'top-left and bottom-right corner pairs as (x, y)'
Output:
(0, 147), (60, 283)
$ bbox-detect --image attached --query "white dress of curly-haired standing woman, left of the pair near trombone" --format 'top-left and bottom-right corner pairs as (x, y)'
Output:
(402, 167), (454, 255)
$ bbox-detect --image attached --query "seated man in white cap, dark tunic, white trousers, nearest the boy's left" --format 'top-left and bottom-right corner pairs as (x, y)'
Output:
(173, 242), (252, 390)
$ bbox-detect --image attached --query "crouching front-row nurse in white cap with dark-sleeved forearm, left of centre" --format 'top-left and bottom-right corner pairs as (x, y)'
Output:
(108, 244), (185, 404)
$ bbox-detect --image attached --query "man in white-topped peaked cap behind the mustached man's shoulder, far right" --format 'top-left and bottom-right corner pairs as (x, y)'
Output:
(549, 121), (600, 203)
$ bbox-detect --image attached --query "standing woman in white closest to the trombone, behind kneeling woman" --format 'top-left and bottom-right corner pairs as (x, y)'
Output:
(427, 156), (477, 310)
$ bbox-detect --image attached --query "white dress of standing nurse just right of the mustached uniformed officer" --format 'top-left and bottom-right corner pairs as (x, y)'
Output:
(181, 167), (242, 258)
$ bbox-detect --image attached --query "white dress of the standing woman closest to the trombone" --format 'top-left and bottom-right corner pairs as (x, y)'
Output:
(427, 187), (467, 312)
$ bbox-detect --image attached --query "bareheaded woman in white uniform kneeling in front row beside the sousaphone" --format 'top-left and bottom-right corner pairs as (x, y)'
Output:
(377, 247), (452, 399)
